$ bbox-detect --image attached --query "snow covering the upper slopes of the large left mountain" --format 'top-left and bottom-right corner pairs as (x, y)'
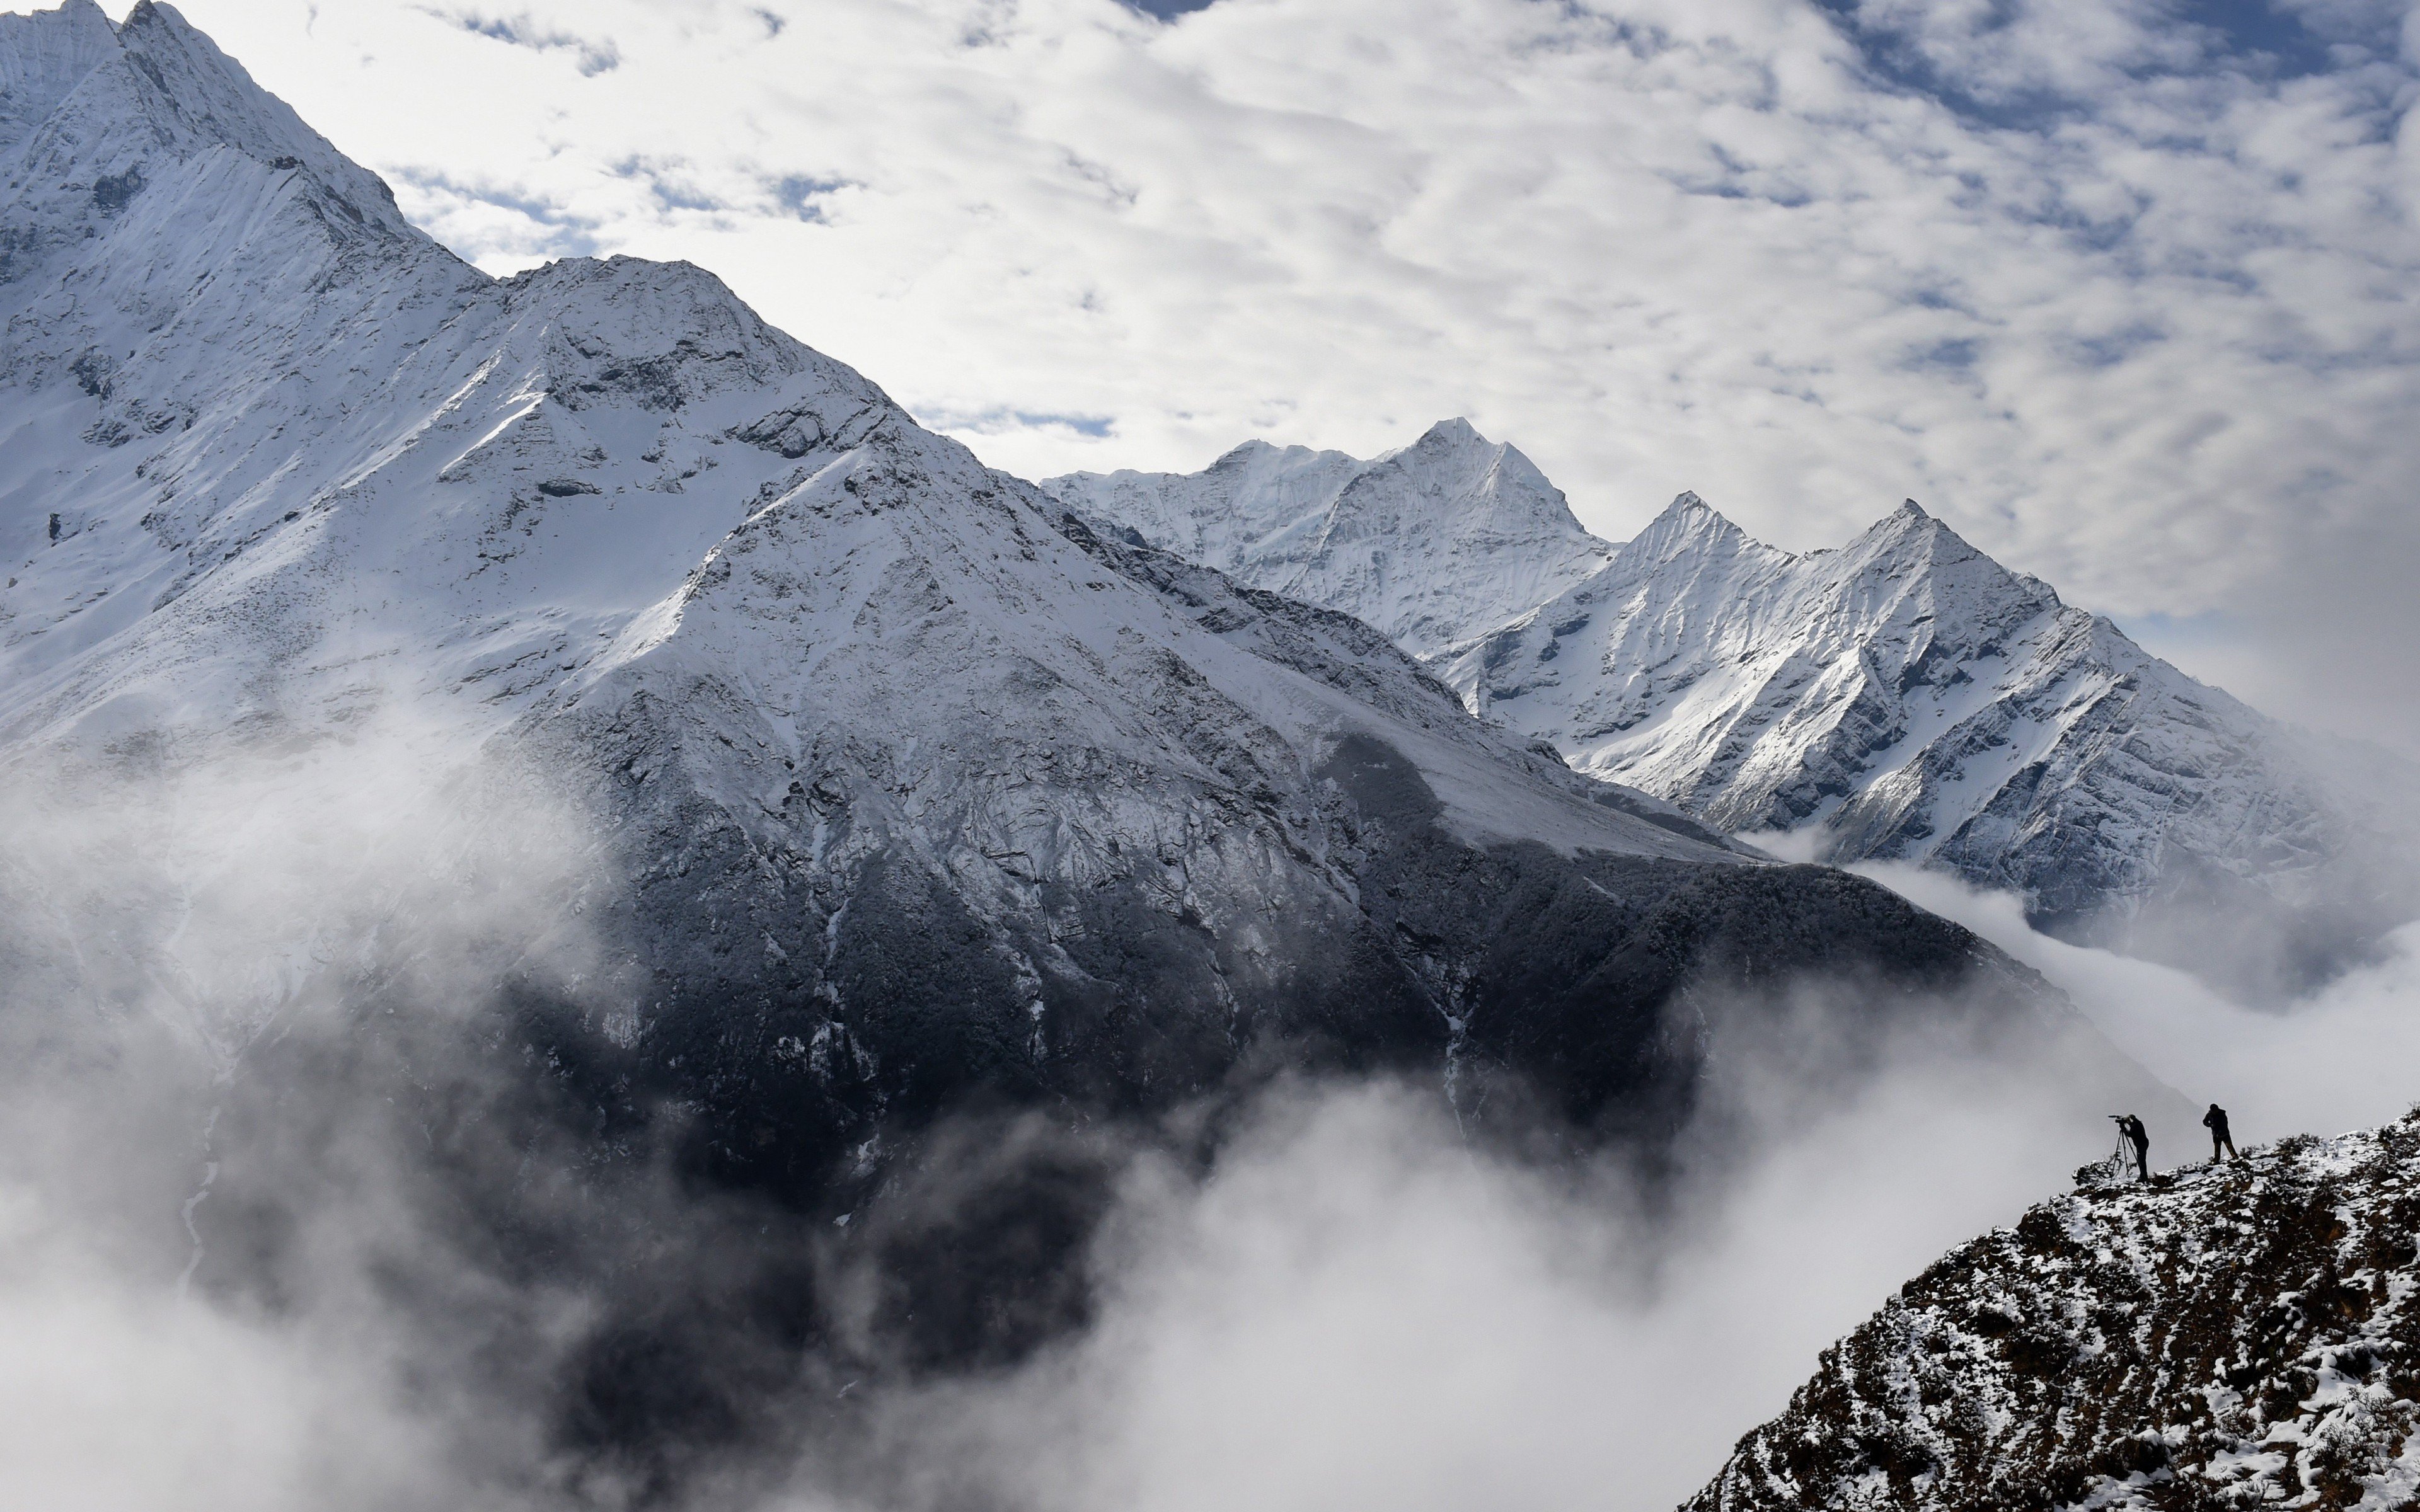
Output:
(0, 8), (1749, 1050)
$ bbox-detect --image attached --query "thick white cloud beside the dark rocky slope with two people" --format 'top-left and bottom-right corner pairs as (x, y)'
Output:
(827, 992), (2178, 1512)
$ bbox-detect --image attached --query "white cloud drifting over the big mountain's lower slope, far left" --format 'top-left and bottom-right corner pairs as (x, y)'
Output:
(0, 718), (614, 1512)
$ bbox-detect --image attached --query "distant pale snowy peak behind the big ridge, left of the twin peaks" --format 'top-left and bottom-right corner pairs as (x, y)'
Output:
(1043, 421), (1611, 658)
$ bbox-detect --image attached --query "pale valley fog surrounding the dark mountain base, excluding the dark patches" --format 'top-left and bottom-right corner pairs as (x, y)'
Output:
(0, 738), (2420, 1512)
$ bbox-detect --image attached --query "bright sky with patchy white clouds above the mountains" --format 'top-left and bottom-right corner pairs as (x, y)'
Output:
(52, 0), (2420, 750)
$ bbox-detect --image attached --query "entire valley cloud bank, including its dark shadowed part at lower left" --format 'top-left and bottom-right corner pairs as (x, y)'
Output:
(0, 696), (2390, 1512)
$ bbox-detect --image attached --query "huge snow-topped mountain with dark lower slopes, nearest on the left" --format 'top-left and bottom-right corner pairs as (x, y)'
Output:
(0, 0), (2100, 1188)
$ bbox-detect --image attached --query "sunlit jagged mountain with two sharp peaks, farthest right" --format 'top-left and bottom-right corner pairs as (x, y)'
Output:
(1443, 493), (2420, 994)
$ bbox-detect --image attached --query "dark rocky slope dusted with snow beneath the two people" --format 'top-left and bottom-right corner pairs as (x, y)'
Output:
(1686, 1118), (2420, 1512)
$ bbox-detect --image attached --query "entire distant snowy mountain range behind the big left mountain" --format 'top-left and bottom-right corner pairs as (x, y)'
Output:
(1043, 435), (2420, 999)
